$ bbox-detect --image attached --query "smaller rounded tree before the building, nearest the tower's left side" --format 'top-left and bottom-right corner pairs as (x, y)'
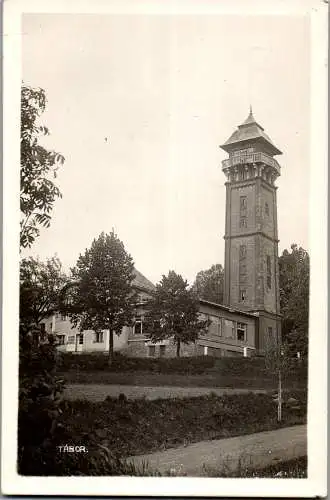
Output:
(145, 271), (208, 357)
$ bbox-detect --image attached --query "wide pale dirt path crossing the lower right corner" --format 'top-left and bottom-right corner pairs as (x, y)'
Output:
(128, 425), (307, 476)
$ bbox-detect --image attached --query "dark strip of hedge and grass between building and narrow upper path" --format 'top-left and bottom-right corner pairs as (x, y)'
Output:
(58, 353), (307, 389)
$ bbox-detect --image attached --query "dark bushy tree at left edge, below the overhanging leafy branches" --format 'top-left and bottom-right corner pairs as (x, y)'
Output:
(20, 257), (67, 340)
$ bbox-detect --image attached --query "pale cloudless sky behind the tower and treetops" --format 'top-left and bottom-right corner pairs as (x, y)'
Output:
(22, 14), (310, 283)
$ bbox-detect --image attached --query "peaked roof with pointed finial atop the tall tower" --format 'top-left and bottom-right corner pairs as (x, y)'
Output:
(220, 106), (282, 155)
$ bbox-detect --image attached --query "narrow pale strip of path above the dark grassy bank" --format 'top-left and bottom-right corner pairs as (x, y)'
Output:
(64, 384), (266, 402)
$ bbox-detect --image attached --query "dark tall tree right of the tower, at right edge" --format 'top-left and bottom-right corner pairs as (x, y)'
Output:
(279, 244), (309, 356)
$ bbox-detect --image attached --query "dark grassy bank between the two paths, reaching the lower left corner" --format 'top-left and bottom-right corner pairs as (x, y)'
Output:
(20, 391), (306, 475)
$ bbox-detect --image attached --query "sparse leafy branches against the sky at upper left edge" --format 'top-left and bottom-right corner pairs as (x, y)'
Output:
(20, 85), (64, 248)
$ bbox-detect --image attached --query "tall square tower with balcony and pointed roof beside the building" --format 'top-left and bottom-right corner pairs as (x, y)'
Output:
(221, 109), (282, 354)
